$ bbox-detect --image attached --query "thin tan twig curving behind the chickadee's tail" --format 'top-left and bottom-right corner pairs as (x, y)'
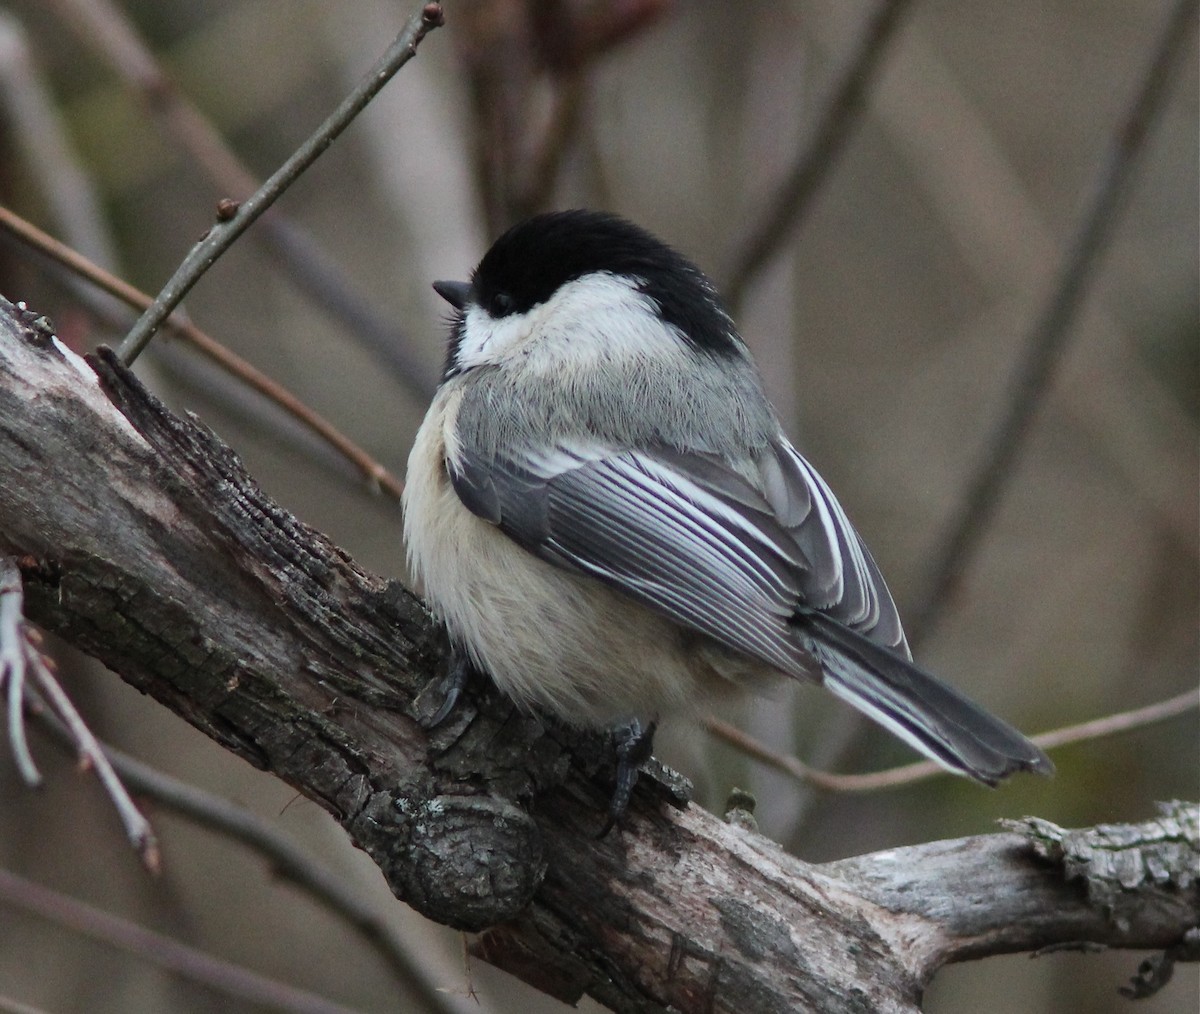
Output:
(704, 690), (1200, 792)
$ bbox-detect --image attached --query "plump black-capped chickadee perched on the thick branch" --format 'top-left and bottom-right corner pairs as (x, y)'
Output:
(404, 211), (1052, 809)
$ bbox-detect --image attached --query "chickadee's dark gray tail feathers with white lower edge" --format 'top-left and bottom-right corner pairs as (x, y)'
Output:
(802, 613), (1054, 785)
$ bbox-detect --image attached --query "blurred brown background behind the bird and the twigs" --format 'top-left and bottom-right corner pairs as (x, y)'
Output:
(0, 0), (1200, 1014)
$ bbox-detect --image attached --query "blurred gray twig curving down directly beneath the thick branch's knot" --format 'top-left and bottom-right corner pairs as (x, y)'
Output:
(46, 722), (452, 1014)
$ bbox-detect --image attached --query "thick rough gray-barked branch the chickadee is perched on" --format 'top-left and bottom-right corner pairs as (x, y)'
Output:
(0, 295), (1200, 1012)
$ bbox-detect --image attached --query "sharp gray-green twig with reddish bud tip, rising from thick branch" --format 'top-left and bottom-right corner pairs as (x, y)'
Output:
(120, 4), (443, 365)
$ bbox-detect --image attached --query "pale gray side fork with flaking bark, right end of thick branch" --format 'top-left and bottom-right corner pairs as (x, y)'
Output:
(822, 803), (1200, 967)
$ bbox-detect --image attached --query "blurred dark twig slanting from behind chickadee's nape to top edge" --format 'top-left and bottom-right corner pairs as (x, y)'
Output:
(722, 0), (908, 308)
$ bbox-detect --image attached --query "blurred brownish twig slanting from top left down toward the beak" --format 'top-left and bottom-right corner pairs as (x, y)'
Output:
(47, 0), (431, 397)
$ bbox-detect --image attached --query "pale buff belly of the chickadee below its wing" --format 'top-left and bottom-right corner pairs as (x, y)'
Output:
(404, 388), (772, 725)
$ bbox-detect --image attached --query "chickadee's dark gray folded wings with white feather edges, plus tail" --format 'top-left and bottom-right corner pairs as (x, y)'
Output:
(450, 440), (1051, 784)
